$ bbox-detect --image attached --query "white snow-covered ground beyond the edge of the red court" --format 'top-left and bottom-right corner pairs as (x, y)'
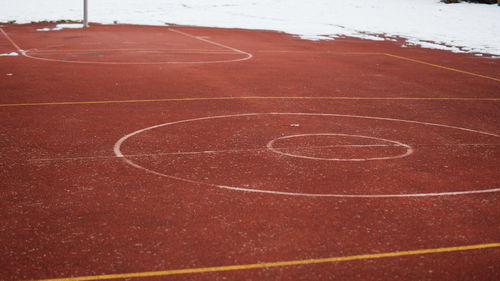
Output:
(0, 0), (500, 55)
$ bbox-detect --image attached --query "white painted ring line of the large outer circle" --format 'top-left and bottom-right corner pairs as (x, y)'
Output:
(113, 112), (500, 198)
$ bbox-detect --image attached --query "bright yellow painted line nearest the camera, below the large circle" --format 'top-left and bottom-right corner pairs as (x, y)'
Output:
(32, 243), (500, 281)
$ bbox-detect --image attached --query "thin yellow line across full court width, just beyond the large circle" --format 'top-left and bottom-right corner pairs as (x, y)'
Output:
(0, 96), (500, 107)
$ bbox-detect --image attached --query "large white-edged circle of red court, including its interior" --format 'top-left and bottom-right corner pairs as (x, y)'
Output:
(113, 112), (500, 198)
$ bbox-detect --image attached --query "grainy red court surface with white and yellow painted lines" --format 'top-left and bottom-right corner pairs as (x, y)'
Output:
(0, 24), (500, 280)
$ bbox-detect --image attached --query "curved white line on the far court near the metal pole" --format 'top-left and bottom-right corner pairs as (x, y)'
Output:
(0, 25), (253, 65)
